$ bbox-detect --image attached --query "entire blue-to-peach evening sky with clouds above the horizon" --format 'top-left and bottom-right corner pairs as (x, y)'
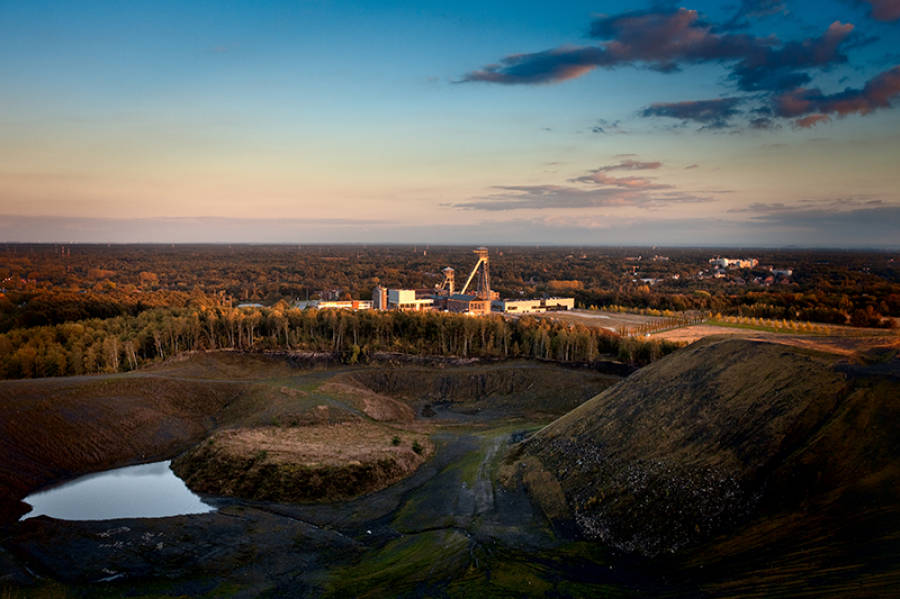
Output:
(0, 0), (900, 248)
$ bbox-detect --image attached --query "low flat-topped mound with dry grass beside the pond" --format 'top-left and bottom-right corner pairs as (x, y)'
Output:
(172, 422), (434, 502)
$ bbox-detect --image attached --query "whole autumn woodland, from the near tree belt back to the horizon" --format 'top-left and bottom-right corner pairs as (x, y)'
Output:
(0, 244), (900, 377)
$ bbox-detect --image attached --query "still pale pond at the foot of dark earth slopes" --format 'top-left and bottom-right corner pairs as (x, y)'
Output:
(21, 460), (215, 520)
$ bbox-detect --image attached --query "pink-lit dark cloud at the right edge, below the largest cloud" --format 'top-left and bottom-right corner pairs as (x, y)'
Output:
(774, 66), (900, 119)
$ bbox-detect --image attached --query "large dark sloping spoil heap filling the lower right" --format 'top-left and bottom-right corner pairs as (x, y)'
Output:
(504, 338), (900, 564)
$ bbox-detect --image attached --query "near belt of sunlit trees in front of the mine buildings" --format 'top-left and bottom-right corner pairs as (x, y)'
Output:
(0, 304), (678, 378)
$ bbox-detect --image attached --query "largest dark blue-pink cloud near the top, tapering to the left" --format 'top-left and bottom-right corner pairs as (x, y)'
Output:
(462, 8), (853, 91)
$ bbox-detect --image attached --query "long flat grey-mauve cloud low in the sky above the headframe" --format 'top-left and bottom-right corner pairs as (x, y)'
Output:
(453, 185), (713, 211)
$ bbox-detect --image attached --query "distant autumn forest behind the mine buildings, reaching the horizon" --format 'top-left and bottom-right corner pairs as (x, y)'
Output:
(0, 244), (900, 332)
